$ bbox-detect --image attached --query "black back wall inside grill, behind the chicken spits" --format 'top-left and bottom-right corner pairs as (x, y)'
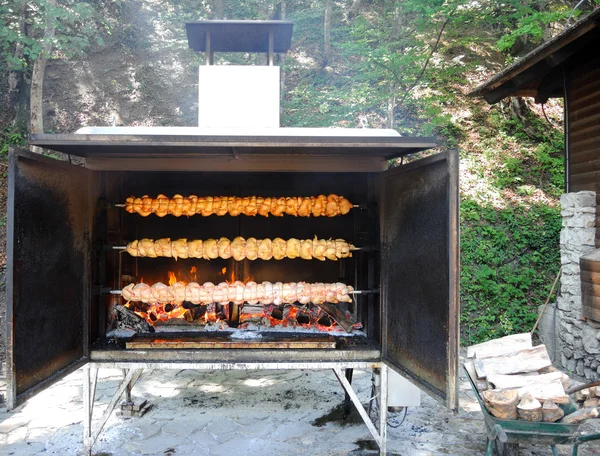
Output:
(95, 169), (380, 340)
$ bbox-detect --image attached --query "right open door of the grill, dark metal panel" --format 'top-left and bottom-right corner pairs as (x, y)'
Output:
(380, 151), (459, 409)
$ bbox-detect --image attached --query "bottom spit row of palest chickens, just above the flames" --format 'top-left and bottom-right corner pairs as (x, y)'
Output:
(121, 281), (354, 305)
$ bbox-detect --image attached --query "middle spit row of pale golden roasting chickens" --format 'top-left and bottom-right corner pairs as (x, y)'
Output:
(127, 236), (355, 261)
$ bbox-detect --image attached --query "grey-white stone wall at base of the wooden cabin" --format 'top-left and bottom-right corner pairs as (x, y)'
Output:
(546, 191), (600, 381)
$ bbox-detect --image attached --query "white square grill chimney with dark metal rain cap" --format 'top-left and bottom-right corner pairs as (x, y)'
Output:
(185, 21), (293, 128)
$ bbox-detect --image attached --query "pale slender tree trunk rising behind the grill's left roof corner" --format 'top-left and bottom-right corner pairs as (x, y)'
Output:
(29, 0), (56, 133)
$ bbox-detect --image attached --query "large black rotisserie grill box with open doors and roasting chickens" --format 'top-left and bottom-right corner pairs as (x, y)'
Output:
(7, 130), (458, 454)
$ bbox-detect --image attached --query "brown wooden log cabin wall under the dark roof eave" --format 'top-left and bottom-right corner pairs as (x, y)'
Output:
(567, 59), (600, 248)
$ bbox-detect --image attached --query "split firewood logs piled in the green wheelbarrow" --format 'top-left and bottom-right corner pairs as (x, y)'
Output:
(465, 333), (600, 424)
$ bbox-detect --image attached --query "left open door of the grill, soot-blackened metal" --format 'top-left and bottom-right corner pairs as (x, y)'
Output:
(6, 150), (92, 409)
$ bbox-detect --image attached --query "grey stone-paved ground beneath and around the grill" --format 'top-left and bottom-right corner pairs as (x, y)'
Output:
(0, 360), (600, 456)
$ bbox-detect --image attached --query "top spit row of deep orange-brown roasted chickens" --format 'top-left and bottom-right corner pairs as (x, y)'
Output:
(125, 194), (352, 217)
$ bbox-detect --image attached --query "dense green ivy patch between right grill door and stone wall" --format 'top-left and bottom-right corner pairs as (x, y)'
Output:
(461, 198), (561, 344)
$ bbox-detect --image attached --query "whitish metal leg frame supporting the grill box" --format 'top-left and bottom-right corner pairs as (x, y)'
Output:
(83, 361), (388, 456)
